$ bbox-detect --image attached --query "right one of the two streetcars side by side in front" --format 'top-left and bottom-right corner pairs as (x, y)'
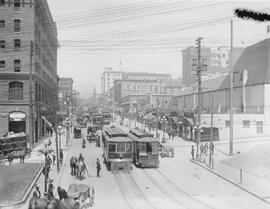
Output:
(129, 129), (159, 167)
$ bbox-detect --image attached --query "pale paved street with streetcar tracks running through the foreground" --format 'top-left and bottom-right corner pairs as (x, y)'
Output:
(51, 125), (270, 209)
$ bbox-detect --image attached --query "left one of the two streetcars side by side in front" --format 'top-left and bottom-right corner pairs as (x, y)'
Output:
(102, 126), (133, 170)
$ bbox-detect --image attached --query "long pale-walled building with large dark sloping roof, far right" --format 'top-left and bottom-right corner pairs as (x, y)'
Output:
(172, 39), (270, 139)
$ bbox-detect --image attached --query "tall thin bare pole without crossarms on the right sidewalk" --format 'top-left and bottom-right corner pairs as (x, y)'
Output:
(230, 20), (233, 155)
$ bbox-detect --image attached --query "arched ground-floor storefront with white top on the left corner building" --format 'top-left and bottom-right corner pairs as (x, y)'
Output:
(8, 112), (26, 133)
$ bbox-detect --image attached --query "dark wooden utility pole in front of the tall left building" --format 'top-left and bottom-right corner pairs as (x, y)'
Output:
(29, 41), (34, 150)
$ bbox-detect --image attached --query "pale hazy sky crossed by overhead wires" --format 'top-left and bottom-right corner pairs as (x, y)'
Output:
(47, 0), (270, 98)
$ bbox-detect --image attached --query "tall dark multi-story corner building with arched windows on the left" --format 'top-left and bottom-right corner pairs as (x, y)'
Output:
(0, 0), (58, 145)
